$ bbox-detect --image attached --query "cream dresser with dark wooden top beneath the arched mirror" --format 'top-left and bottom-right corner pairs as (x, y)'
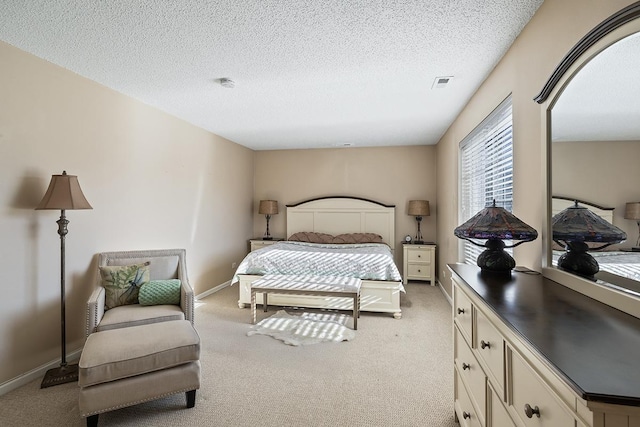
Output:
(448, 264), (640, 427)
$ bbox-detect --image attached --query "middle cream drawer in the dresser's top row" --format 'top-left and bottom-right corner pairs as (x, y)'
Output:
(476, 310), (504, 395)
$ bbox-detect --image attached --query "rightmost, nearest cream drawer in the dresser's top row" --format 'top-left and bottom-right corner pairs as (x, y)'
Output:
(507, 350), (575, 427)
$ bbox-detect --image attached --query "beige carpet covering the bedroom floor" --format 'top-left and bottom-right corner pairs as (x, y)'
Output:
(0, 283), (456, 427)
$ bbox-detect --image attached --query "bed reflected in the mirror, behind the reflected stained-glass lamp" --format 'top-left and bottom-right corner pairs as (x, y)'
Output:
(552, 196), (640, 289)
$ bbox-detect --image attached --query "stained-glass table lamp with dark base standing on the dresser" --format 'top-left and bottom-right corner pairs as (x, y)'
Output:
(453, 200), (538, 273)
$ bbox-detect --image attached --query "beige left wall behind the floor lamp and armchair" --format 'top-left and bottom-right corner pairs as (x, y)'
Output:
(0, 43), (253, 385)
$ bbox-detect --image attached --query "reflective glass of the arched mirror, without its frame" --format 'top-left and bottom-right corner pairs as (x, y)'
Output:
(550, 33), (640, 295)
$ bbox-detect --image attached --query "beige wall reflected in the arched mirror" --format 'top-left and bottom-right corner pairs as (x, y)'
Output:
(552, 141), (640, 244)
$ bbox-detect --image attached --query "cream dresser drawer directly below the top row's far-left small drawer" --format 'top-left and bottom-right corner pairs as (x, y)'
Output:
(453, 328), (487, 424)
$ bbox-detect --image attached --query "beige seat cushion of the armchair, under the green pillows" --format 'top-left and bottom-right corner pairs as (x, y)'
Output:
(96, 304), (185, 332)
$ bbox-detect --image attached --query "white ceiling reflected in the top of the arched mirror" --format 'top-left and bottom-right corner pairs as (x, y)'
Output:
(551, 33), (640, 141)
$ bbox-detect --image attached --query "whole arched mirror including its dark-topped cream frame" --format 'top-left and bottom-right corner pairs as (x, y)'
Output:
(535, 2), (640, 316)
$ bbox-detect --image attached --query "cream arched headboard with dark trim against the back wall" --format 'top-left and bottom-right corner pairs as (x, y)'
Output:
(287, 197), (395, 249)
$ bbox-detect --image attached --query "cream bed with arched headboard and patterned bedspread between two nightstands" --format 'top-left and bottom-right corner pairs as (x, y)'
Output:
(232, 197), (404, 319)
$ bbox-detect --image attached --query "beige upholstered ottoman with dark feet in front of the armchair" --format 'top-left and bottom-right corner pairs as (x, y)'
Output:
(78, 320), (200, 426)
